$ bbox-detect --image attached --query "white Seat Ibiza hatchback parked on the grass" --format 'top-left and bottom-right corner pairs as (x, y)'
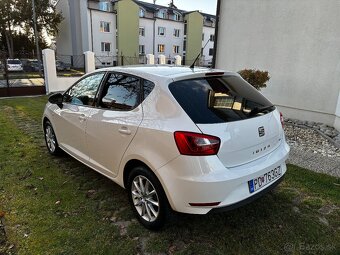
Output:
(43, 66), (289, 229)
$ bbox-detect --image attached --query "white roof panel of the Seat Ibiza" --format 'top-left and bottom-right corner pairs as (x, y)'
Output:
(91, 65), (235, 80)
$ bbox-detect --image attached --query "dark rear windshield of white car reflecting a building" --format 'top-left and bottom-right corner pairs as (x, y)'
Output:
(169, 76), (275, 124)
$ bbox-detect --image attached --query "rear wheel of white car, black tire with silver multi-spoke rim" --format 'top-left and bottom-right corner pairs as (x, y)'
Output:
(127, 166), (171, 230)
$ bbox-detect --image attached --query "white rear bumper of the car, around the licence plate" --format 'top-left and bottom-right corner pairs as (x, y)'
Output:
(157, 141), (289, 214)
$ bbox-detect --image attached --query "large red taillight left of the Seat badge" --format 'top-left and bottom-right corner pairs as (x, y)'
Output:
(174, 131), (221, 156)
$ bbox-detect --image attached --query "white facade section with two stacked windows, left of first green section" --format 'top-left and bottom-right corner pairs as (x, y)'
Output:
(89, 10), (117, 66)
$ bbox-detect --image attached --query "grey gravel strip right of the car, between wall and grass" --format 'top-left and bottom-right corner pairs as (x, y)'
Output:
(285, 125), (340, 177)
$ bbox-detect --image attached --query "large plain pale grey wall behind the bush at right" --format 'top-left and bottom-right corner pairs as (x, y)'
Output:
(216, 0), (340, 126)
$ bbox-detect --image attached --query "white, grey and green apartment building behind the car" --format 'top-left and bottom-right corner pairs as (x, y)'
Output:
(56, 0), (215, 66)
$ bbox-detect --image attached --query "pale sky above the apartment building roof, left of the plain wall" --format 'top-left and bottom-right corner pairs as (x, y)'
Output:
(142, 0), (217, 15)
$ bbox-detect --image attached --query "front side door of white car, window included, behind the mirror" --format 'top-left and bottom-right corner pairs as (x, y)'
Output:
(54, 72), (105, 161)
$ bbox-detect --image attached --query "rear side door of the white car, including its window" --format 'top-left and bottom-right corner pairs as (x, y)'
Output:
(86, 72), (143, 177)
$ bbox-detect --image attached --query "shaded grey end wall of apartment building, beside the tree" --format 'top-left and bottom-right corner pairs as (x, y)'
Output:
(56, 0), (72, 55)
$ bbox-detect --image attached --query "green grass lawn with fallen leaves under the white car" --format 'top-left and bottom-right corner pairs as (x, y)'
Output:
(0, 97), (340, 254)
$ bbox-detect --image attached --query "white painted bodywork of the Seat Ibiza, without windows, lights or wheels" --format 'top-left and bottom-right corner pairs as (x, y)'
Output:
(43, 66), (289, 214)
